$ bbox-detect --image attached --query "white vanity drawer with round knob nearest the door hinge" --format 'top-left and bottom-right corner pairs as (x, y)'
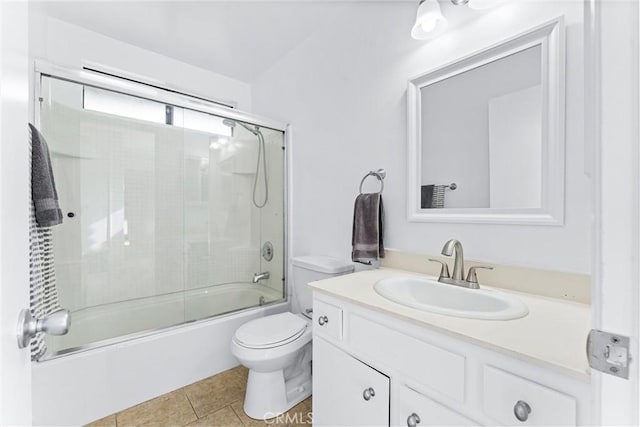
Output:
(483, 366), (576, 426)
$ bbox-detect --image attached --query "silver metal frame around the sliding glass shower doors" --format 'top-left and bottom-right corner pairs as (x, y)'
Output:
(31, 59), (293, 354)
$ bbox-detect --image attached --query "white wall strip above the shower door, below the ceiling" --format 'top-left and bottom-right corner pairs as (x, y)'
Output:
(29, 2), (251, 111)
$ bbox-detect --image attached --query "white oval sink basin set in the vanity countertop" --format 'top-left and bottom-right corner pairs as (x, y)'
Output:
(373, 277), (529, 320)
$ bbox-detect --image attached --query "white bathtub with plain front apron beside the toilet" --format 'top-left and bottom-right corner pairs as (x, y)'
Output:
(32, 283), (290, 425)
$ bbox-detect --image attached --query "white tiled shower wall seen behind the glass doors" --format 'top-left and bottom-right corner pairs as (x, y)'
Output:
(41, 77), (284, 310)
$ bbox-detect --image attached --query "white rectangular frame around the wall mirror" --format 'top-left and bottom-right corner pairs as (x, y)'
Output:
(407, 17), (565, 225)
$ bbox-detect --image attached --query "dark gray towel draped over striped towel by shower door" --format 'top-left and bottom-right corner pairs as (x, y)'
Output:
(29, 123), (62, 227)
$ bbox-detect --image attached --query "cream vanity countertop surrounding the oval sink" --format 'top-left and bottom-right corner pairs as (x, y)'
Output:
(309, 268), (591, 380)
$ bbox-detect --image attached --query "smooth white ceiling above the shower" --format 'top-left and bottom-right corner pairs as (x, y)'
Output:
(38, 1), (400, 83)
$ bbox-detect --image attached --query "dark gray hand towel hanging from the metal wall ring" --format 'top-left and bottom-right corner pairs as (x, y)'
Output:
(351, 193), (384, 264)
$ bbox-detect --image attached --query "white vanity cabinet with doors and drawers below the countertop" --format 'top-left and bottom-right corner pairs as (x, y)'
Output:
(313, 291), (591, 427)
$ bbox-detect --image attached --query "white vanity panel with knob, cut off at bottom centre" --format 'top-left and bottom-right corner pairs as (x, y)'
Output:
(391, 386), (478, 427)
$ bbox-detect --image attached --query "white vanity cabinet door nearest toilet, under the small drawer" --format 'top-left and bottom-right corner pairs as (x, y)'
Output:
(313, 336), (389, 426)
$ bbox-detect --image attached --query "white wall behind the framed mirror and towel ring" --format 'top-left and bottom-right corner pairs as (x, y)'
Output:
(252, 1), (590, 273)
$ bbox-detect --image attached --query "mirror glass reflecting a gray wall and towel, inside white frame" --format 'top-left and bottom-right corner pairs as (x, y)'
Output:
(420, 45), (542, 208)
